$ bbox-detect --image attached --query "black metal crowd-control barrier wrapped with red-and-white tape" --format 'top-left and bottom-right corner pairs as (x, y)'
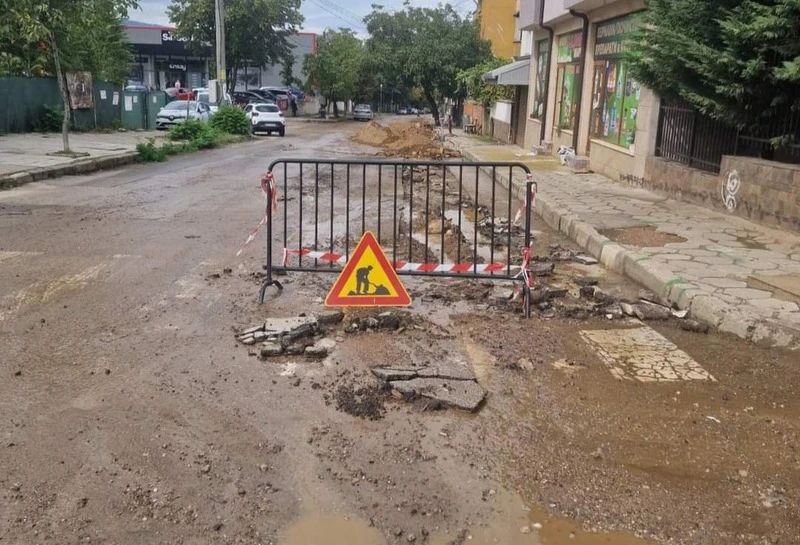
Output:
(258, 159), (536, 316)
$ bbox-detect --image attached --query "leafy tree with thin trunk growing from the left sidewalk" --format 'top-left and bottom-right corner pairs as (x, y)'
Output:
(0, 0), (138, 154)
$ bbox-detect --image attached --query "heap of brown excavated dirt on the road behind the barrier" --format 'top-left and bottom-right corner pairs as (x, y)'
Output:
(353, 121), (458, 159)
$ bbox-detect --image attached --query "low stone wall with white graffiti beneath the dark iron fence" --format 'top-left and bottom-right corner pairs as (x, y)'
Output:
(644, 155), (800, 232)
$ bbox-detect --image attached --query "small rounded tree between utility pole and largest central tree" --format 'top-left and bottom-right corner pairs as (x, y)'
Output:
(303, 29), (366, 117)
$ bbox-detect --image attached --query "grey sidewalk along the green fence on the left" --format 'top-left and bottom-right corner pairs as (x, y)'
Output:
(0, 131), (163, 189)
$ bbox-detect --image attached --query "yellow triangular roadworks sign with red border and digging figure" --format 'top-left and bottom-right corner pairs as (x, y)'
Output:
(325, 231), (411, 307)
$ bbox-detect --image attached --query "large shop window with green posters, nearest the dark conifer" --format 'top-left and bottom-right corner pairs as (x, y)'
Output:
(590, 16), (641, 149)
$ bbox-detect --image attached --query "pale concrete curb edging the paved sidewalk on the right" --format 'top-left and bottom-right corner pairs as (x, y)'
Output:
(451, 142), (800, 349)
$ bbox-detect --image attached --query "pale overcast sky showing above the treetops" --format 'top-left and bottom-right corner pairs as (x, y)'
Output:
(130, 0), (475, 33)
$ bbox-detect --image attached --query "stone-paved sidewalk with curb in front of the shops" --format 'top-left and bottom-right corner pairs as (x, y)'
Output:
(448, 133), (800, 349)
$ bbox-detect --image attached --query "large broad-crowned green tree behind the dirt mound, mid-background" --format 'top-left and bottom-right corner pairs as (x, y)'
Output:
(365, 3), (492, 125)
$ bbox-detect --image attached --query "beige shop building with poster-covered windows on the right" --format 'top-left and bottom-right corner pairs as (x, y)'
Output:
(519, 0), (659, 183)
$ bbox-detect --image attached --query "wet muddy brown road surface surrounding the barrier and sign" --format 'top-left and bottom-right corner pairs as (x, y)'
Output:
(0, 121), (800, 545)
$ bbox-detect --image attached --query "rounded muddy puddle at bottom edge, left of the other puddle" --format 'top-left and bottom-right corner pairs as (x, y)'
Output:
(279, 515), (386, 545)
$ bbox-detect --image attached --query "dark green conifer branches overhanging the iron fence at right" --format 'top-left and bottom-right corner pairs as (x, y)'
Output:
(629, 0), (800, 128)
